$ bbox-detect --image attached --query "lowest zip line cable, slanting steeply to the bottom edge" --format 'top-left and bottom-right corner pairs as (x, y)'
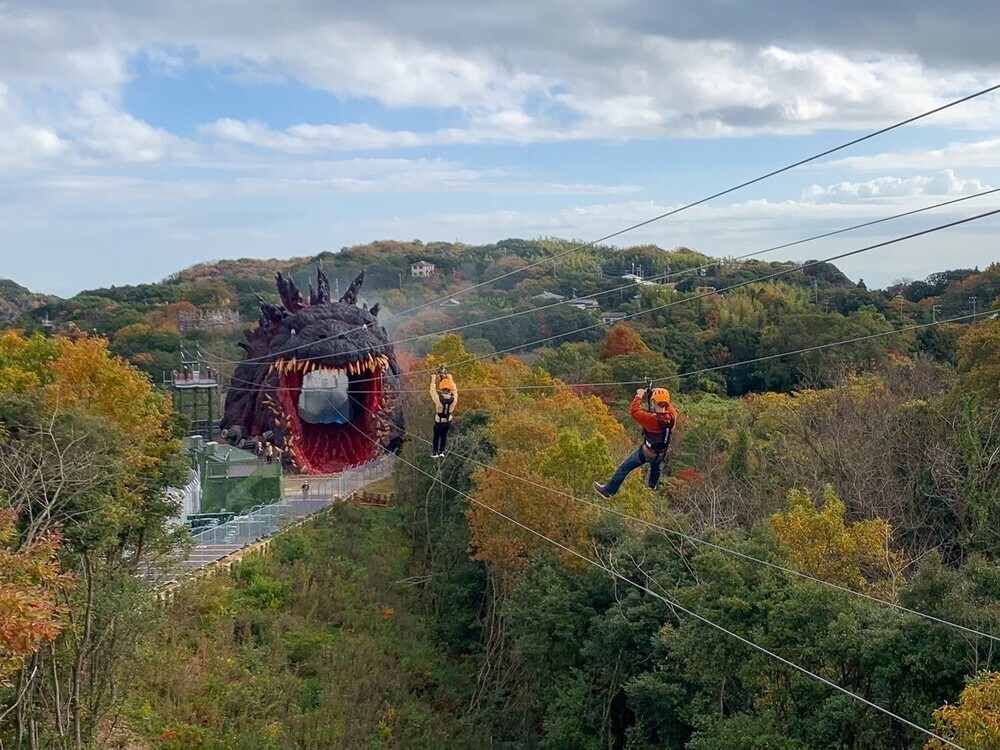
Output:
(352, 425), (964, 750)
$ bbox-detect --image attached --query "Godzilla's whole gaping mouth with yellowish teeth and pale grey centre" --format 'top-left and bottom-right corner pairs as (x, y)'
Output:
(265, 355), (389, 474)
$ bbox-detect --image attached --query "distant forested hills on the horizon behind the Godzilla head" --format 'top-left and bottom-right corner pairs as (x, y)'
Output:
(0, 239), (1000, 395)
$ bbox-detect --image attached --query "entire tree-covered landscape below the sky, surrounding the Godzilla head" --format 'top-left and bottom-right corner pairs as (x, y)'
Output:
(0, 241), (1000, 750)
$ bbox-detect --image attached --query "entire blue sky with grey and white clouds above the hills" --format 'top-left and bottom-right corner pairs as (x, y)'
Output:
(0, 0), (1000, 296)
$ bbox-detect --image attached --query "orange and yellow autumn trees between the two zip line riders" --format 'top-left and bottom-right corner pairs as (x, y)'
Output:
(422, 336), (634, 573)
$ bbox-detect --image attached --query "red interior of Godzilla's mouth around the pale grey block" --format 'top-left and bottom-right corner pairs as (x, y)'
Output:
(278, 371), (382, 474)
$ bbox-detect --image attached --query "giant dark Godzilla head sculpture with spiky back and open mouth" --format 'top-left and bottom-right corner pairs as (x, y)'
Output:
(222, 271), (403, 474)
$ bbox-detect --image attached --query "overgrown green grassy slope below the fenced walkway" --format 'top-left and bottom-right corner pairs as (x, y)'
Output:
(130, 505), (482, 750)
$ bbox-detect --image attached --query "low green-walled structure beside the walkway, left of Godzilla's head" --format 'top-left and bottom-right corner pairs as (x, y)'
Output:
(184, 435), (282, 513)
